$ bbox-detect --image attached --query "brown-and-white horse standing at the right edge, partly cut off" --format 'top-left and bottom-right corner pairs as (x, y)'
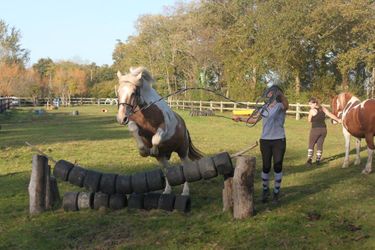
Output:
(332, 92), (375, 174)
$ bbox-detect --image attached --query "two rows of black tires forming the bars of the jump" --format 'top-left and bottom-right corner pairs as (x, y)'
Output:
(53, 152), (234, 212)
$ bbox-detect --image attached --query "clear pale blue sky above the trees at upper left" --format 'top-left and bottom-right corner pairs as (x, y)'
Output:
(0, 0), (181, 65)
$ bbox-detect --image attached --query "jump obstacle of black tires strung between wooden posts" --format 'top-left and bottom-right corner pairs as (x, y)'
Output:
(30, 148), (255, 218)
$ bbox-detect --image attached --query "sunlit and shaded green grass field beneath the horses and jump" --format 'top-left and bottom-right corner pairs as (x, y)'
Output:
(0, 106), (375, 249)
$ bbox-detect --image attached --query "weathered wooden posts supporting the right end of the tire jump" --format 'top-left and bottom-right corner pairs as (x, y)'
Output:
(223, 143), (258, 219)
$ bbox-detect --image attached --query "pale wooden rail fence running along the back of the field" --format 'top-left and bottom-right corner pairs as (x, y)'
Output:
(0, 97), (329, 120)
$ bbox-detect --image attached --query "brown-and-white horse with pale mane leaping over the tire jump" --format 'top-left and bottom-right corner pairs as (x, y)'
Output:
(117, 67), (202, 195)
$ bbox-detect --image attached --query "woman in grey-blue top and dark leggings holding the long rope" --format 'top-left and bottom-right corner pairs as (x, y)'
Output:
(235, 86), (289, 203)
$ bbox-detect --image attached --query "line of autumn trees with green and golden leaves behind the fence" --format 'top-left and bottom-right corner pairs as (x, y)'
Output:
(0, 0), (375, 101)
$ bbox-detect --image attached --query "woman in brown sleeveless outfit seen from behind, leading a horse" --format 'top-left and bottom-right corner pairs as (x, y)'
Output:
(306, 97), (341, 167)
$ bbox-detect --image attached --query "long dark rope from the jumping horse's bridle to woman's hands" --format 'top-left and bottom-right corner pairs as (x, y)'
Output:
(118, 85), (282, 127)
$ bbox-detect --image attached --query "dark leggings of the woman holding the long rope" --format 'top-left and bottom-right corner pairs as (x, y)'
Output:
(260, 138), (286, 174)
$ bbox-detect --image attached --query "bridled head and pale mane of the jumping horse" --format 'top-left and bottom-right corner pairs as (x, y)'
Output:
(116, 67), (153, 125)
